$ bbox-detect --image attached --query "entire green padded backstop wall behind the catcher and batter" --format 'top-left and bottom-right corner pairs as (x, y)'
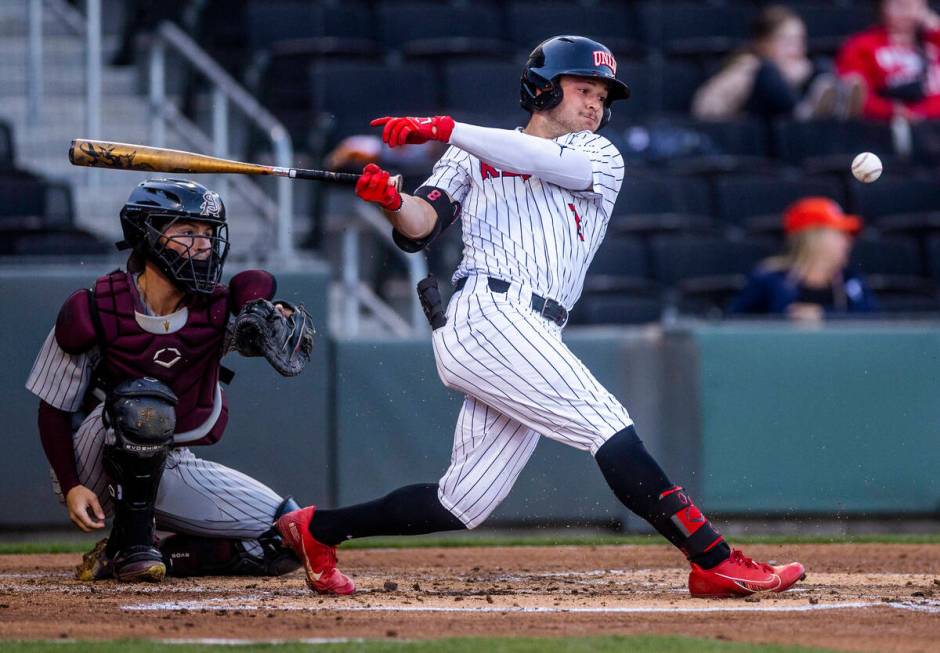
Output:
(7, 263), (940, 527)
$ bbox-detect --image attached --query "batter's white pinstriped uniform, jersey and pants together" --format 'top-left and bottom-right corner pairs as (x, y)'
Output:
(425, 126), (633, 528)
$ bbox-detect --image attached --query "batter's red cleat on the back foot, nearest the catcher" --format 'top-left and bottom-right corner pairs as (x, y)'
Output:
(277, 506), (356, 594)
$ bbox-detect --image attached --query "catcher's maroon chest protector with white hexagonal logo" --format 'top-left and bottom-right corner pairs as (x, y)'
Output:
(92, 270), (229, 445)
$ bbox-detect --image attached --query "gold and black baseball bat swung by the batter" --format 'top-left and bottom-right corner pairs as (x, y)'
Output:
(69, 138), (401, 188)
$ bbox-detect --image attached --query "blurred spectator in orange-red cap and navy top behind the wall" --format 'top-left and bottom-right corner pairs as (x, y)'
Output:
(730, 197), (876, 321)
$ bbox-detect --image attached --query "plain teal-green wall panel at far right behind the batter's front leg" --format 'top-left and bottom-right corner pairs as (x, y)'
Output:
(691, 324), (940, 514)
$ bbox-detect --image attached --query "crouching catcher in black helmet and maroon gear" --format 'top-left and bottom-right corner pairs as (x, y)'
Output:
(26, 179), (313, 581)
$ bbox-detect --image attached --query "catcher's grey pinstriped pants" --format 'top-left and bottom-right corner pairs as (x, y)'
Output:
(66, 404), (283, 539)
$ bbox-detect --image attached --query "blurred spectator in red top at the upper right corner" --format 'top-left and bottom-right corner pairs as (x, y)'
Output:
(836, 0), (940, 120)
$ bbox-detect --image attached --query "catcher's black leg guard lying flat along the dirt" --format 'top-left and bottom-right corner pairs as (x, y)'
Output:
(160, 497), (300, 576)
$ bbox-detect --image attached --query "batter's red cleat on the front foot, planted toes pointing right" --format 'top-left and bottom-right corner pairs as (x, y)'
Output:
(689, 549), (806, 598)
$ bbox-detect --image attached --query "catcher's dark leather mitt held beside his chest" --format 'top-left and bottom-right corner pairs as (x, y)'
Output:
(232, 299), (313, 376)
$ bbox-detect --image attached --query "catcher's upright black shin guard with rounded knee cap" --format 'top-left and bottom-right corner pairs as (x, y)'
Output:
(103, 378), (176, 581)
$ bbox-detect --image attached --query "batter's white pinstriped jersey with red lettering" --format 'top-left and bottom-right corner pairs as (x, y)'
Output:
(424, 131), (624, 310)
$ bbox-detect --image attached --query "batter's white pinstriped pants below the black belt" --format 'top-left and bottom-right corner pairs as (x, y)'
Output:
(433, 275), (633, 528)
